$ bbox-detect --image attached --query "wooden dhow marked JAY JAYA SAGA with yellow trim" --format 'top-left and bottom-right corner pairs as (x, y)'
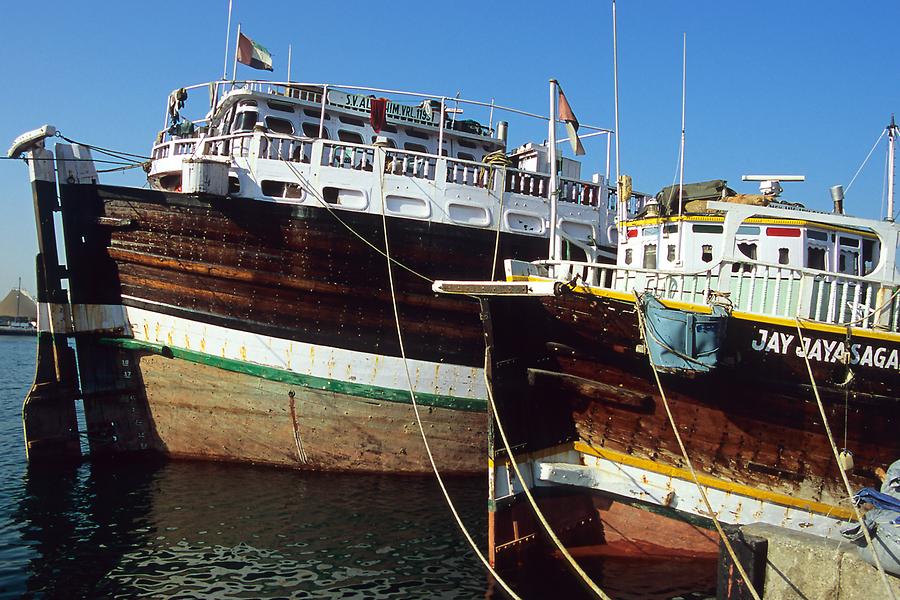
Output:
(434, 122), (900, 565)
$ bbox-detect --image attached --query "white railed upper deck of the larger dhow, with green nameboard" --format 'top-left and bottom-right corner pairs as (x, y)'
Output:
(148, 81), (615, 257)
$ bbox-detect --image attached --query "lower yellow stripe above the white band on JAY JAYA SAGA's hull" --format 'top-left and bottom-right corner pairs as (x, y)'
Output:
(574, 441), (853, 519)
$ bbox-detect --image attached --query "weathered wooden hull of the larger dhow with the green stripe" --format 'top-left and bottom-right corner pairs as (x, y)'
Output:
(52, 180), (564, 473)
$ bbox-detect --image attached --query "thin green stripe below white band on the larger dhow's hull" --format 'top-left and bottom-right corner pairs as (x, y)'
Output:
(100, 338), (487, 412)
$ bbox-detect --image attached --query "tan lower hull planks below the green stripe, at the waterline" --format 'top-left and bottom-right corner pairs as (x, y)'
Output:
(138, 355), (487, 474)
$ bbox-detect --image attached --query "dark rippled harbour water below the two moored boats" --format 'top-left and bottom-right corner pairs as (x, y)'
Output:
(0, 336), (716, 598)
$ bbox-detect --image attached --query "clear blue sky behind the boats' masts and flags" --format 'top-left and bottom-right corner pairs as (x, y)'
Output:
(0, 0), (900, 295)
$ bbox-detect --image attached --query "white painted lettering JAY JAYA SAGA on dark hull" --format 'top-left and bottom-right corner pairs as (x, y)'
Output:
(750, 328), (900, 371)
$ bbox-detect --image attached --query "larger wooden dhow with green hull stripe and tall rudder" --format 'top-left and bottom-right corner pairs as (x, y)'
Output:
(9, 81), (614, 473)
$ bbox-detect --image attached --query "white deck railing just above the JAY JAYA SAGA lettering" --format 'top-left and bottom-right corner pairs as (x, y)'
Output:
(534, 260), (900, 332)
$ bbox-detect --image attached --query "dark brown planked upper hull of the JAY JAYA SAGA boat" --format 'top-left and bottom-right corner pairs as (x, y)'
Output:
(483, 290), (900, 550)
